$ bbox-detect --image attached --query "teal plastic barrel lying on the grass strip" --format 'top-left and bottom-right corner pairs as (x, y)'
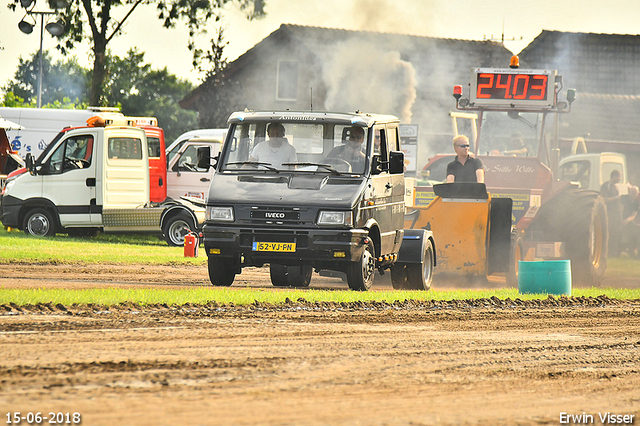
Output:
(518, 260), (571, 296)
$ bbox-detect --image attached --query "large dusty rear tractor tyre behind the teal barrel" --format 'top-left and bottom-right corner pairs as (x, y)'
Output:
(531, 188), (608, 287)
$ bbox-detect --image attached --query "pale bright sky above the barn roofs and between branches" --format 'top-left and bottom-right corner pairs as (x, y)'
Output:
(0, 0), (640, 90)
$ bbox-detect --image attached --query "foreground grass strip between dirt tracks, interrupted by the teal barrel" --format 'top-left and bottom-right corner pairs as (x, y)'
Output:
(0, 287), (640, 306)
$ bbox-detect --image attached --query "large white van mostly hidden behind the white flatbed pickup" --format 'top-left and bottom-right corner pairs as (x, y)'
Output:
(0, 107), (114, 158)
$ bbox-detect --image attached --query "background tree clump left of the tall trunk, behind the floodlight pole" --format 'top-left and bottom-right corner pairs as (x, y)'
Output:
(2, 51), (90, 108)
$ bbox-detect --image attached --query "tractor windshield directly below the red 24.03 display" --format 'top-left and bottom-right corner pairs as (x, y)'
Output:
(479, 112), (542, 157)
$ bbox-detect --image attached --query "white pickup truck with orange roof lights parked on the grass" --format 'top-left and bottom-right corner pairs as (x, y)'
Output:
(0, 117), (204, 246)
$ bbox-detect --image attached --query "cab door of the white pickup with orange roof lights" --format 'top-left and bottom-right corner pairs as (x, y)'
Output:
(40, 132), (101, 227)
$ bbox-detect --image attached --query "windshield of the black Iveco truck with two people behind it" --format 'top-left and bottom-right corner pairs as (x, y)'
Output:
(218, 122), (370, 174)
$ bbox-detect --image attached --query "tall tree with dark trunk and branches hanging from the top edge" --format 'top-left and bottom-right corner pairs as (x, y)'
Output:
(8, 0), (266, 105)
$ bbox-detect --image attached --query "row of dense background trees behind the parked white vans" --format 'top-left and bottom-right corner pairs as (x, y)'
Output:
(2, 49), (198, 142)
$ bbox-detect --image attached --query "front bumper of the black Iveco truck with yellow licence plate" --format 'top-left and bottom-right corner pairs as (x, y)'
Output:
(203, 224), (368, 269)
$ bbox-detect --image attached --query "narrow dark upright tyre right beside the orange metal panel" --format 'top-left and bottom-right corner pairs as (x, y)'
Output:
(487, 198), (513, 275)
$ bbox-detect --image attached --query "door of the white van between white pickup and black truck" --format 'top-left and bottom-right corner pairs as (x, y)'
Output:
(167, 143), (215, 200)
